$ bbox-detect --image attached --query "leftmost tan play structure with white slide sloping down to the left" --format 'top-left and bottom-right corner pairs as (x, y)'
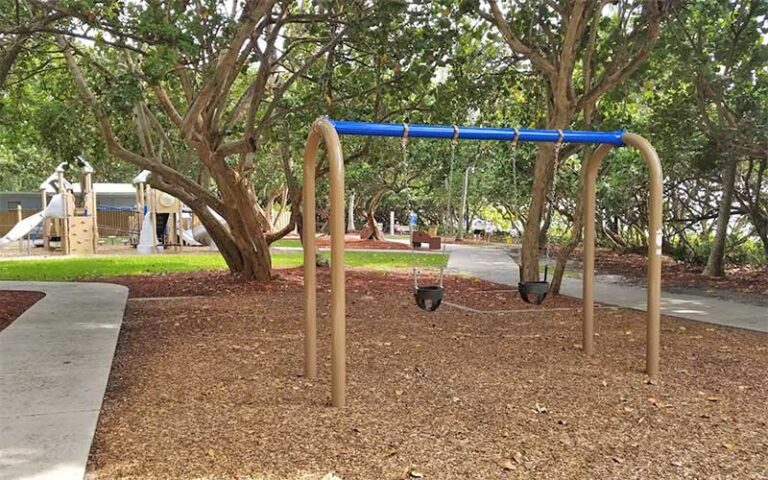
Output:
(0, 157), (99, 255)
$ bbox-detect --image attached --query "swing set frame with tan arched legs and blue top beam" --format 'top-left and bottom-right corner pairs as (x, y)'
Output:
(302, 117), (663, 407)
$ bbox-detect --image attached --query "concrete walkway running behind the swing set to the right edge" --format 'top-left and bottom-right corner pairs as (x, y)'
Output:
(448, 245), (768, 333)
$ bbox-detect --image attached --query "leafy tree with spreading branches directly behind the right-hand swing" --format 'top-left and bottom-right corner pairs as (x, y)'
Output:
(474, 0), (664, 284)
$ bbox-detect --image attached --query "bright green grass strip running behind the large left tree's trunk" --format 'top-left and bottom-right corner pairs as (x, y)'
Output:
(0, 251), (448, 281)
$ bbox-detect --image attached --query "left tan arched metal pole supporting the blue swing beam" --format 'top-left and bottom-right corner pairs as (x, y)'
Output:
(302, 118), (346, 407)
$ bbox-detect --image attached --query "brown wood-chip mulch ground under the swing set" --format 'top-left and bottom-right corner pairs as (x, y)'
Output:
(88, 272), (768, 480)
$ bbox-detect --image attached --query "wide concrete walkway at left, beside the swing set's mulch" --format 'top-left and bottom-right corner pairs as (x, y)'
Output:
(0, 282), (128, 480)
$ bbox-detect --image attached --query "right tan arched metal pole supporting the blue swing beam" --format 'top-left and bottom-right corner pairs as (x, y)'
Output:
(582, 133), (663, 380)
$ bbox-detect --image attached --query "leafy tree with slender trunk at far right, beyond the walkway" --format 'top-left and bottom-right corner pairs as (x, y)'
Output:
(666, 0), (768, 276)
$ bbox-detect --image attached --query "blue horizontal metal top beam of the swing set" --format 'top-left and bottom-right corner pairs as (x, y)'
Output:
(328, 119), (624, 146)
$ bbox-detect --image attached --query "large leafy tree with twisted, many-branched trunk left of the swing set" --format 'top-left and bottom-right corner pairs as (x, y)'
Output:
(3, 1), (371, 280)
